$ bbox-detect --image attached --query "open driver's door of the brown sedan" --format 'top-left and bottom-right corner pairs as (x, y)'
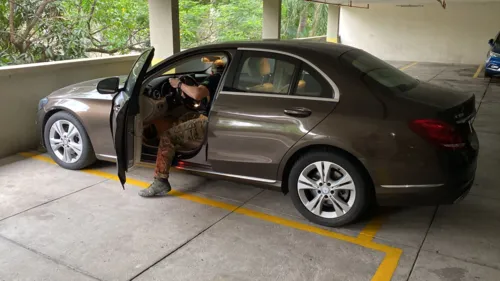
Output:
(110, 48), (154, 188)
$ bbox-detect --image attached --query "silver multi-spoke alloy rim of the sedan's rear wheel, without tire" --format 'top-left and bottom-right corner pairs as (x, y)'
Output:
(297, 161), (356, 219)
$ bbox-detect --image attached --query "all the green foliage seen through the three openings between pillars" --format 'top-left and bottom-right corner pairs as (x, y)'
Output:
(0, 0), (327, 65)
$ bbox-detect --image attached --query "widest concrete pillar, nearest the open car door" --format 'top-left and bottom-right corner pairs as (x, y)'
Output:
(148, 0), (181, 61)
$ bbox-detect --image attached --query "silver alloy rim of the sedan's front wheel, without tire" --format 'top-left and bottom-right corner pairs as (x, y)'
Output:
(49, 120), (83, 163)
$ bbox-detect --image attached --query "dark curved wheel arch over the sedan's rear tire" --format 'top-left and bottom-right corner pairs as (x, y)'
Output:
(280, 144), (375, 198)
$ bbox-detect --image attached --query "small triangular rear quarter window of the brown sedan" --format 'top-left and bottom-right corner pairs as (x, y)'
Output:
(292, 64), (333, 98)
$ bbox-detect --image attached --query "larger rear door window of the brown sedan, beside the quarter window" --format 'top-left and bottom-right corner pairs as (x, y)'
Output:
(233, 53), (296, 95)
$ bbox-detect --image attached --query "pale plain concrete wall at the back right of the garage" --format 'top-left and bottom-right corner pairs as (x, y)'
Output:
(340, 1), (500, 64)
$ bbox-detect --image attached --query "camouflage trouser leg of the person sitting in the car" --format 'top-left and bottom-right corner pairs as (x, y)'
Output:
(155, 112), (208, 179)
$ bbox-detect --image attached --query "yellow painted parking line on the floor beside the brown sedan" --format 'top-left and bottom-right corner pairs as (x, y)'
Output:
(20, 152), (403, 281)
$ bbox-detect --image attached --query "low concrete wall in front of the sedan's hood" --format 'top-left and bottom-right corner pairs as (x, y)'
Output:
(0, 55), (137, 158)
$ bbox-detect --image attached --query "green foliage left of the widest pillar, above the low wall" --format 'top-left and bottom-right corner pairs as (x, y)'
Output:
(0, 0), (149, 65)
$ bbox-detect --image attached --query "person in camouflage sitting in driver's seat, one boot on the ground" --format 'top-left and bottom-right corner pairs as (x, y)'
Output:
(139, 60), (224, 197)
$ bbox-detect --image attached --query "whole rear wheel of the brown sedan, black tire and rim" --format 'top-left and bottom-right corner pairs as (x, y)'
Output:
(288, 151), (373, 227)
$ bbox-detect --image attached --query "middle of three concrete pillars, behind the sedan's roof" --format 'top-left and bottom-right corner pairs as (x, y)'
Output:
(262, 0), (281, 40)
